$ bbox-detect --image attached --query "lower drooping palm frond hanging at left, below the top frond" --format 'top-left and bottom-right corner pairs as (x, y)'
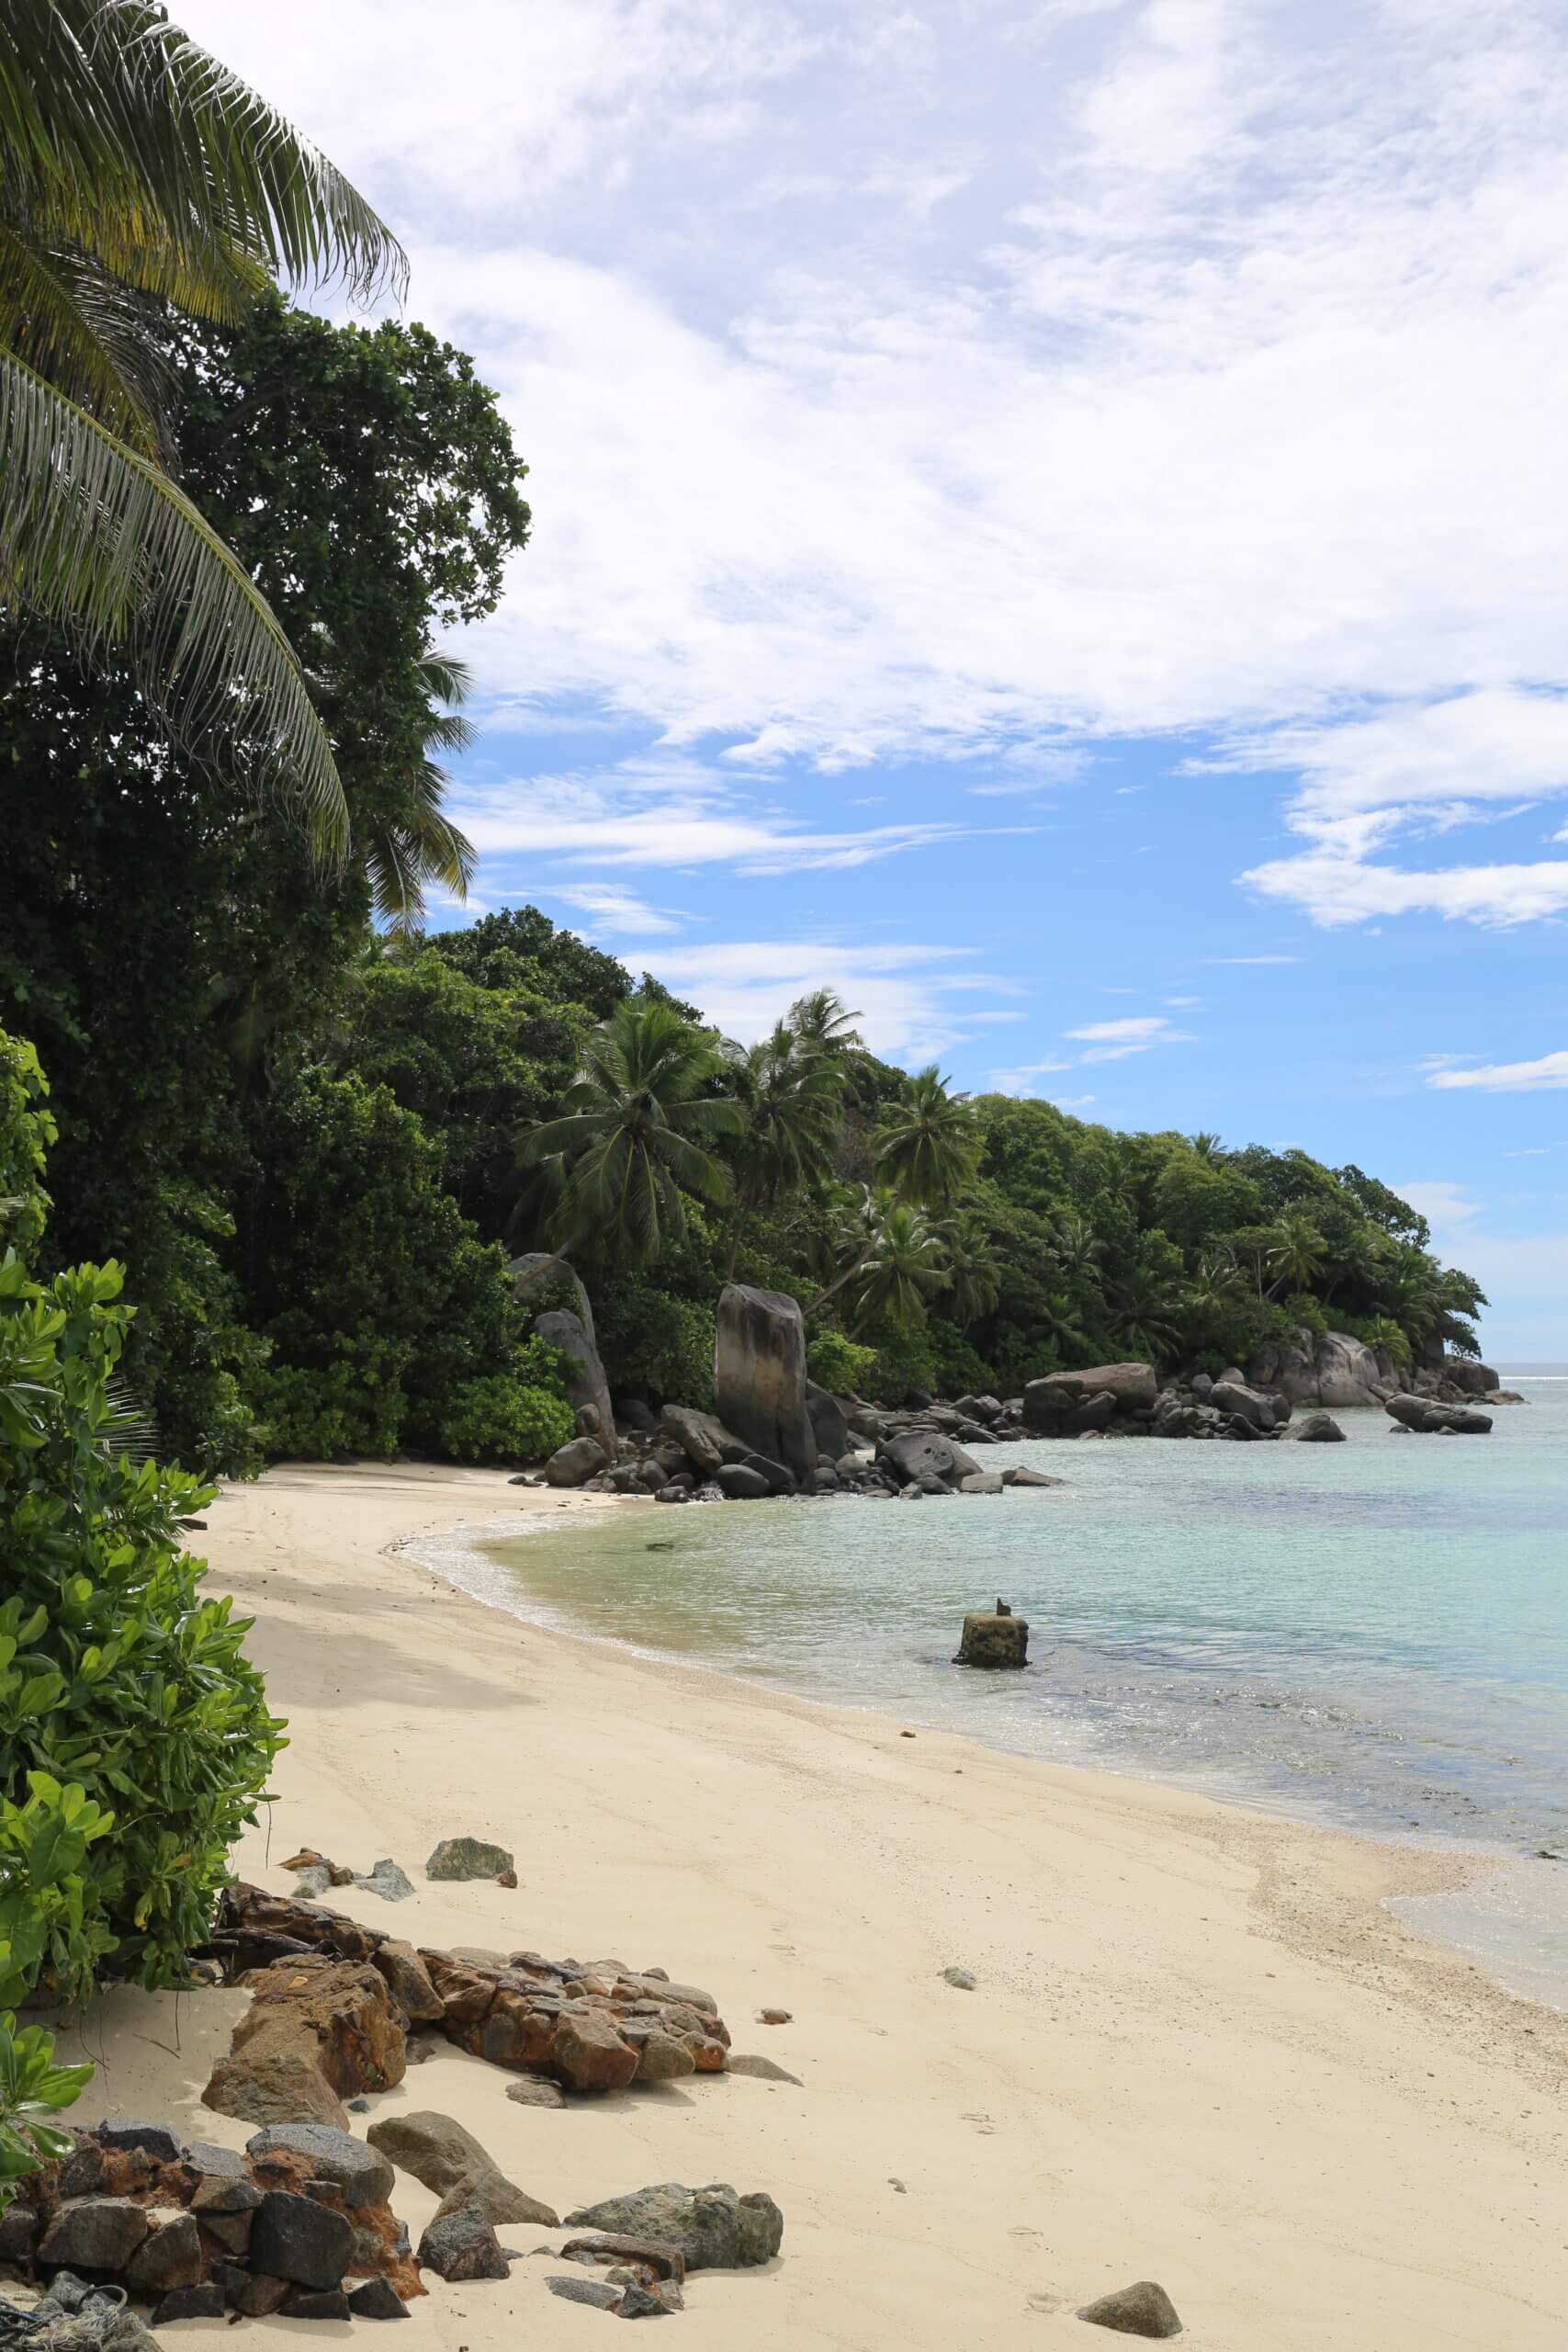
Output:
(0, 350), (348, 858)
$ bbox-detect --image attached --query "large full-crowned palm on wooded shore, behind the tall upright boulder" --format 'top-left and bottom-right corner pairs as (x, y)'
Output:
(520, 997), (743, 1265)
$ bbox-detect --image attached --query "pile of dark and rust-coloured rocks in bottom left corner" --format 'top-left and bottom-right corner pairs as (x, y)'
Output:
(0, 2121), (425, 2334)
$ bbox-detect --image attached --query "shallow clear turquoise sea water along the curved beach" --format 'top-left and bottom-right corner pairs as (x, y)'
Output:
(415, 1366), (1568, 1999)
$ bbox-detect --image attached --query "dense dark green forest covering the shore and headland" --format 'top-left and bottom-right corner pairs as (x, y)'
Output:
(0, 297), (1481, 1473)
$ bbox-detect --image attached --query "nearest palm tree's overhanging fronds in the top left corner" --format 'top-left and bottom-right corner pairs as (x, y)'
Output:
(0, 0), (407, 856)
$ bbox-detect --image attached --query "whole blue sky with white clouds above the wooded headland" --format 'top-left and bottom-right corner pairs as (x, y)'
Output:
(190, 0), (1568, 1360)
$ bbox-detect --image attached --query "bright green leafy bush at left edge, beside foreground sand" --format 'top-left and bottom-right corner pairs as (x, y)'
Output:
(0, 1253), (282, 1996)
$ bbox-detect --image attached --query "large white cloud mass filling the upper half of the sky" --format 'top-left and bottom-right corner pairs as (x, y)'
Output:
(181, 0), (1568, 799)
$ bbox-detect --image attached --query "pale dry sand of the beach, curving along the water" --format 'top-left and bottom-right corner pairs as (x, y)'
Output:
(49, 1470), (1568, 2352)
